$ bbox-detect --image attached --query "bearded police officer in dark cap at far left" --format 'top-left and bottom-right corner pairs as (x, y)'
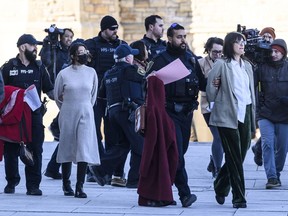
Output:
(2, 34), (53, 196)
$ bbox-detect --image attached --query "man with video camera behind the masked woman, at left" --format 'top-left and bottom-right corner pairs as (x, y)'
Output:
(40, 25), (74, 179)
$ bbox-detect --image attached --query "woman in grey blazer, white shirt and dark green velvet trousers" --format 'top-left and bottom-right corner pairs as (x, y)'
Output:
(206, 32), (255, 208)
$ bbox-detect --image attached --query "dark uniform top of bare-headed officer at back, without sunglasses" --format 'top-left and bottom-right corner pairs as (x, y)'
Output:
(142, 35), (167, 61)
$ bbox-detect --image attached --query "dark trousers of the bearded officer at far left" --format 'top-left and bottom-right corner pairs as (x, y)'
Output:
(4, 111), (44, 190)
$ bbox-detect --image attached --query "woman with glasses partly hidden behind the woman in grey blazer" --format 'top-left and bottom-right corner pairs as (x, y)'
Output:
(198, 37), (223, 178)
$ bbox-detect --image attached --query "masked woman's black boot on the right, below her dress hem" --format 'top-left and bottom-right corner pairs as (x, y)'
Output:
(75, 162), (87, 198)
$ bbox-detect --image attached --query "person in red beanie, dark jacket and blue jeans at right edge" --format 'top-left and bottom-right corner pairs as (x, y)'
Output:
(254, 39), (288, 189)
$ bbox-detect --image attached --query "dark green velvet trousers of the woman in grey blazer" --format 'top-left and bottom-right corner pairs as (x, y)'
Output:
(214, 105), (251, 204)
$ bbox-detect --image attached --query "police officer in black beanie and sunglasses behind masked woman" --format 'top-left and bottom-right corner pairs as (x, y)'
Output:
(85, 15), (127, 183)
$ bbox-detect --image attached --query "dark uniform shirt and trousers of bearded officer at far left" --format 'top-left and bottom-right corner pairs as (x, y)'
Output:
(2, 56), (53, 191)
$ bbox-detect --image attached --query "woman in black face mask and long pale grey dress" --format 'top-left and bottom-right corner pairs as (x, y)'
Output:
(54, 43), (100, 198)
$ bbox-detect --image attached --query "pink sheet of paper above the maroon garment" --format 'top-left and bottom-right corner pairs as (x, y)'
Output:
(154, 58), (190, 85)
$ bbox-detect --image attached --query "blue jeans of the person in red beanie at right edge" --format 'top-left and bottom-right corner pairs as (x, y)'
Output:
(258, 119), (288, 179)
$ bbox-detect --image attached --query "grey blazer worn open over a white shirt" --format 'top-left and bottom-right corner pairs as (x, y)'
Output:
(206, 59), (256, 132)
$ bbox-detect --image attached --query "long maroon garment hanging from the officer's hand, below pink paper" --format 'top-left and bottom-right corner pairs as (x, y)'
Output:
(137, 76), (178, 201)
